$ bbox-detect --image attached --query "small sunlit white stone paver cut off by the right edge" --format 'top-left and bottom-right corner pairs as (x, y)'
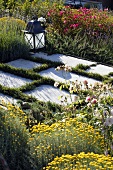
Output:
(87, 64), (113, 75)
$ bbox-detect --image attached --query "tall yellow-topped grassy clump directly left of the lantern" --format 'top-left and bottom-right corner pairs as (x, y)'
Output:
(0, 17), (29, 62)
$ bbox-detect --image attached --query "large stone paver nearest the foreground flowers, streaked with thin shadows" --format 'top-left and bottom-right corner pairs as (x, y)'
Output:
(25, 85), (75, 104)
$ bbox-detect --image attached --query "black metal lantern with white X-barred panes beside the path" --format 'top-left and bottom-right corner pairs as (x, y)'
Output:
(22, 17), (45, 52)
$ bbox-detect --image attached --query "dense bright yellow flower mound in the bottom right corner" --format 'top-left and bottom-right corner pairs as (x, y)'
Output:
(45, 152), (113, 170)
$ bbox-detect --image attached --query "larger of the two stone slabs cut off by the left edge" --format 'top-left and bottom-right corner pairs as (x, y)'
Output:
(0, 71), (32, 88)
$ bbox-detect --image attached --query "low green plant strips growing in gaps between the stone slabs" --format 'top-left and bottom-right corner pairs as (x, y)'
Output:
(0, 57), (113, 105)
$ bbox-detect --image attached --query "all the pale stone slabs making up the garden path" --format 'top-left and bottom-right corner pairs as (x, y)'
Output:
(0, 52), (113, 104)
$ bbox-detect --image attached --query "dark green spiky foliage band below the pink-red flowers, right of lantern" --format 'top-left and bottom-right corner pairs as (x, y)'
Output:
(46, 28), (113, 65)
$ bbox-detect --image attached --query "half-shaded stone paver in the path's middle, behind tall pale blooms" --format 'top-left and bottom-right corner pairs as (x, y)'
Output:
(39, 68), (99, 85)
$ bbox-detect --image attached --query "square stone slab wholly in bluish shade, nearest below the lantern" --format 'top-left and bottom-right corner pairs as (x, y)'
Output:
(7, 59), (42, 69)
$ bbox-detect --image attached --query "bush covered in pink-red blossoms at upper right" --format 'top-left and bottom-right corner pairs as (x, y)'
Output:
(47, 5), (113, 37)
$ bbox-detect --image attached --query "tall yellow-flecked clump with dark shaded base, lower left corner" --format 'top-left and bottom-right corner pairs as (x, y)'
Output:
(0, 101), (35, 170)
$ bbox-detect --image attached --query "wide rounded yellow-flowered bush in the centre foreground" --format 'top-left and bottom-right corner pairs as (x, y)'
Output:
(29, 119), (104, 169)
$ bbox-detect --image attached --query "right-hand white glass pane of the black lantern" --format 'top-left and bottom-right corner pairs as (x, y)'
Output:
(35, 33), (45, 49)
